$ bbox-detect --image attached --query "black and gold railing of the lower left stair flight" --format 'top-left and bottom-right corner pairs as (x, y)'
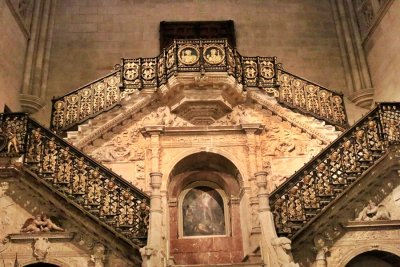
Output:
(0, 113), (149, 245)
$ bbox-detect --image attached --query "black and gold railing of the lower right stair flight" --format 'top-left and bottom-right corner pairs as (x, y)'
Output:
(270, 103), (400, 238)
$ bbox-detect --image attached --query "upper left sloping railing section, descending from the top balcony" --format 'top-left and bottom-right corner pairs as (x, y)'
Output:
(51, 71), (122, 130)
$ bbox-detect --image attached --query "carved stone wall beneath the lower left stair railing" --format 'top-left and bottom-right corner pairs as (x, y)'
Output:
(0, 178), (128, 267)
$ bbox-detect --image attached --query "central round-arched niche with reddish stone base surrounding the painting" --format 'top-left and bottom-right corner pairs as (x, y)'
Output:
(168, 152), (243, 264)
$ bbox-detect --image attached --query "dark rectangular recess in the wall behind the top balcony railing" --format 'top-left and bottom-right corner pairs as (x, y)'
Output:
(160, 20), (236, 51)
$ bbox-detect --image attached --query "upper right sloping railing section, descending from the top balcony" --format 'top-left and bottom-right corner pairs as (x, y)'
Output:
(278, 69), (348, 130)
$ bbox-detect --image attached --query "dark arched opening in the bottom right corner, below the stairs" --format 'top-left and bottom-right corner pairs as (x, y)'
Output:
(346, 250), (400, 267)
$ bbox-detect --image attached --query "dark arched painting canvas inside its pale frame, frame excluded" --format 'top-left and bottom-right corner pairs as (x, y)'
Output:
(182, 186), (225, 236)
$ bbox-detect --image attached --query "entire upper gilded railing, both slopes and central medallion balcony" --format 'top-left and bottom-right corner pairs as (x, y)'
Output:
(51, 39), (347, 130)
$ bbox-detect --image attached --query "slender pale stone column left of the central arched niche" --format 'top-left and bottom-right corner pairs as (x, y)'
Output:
(140, 126), (164, 267)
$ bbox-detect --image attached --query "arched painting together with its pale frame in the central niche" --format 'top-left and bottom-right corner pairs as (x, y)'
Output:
(179, 182), (229, 237)
